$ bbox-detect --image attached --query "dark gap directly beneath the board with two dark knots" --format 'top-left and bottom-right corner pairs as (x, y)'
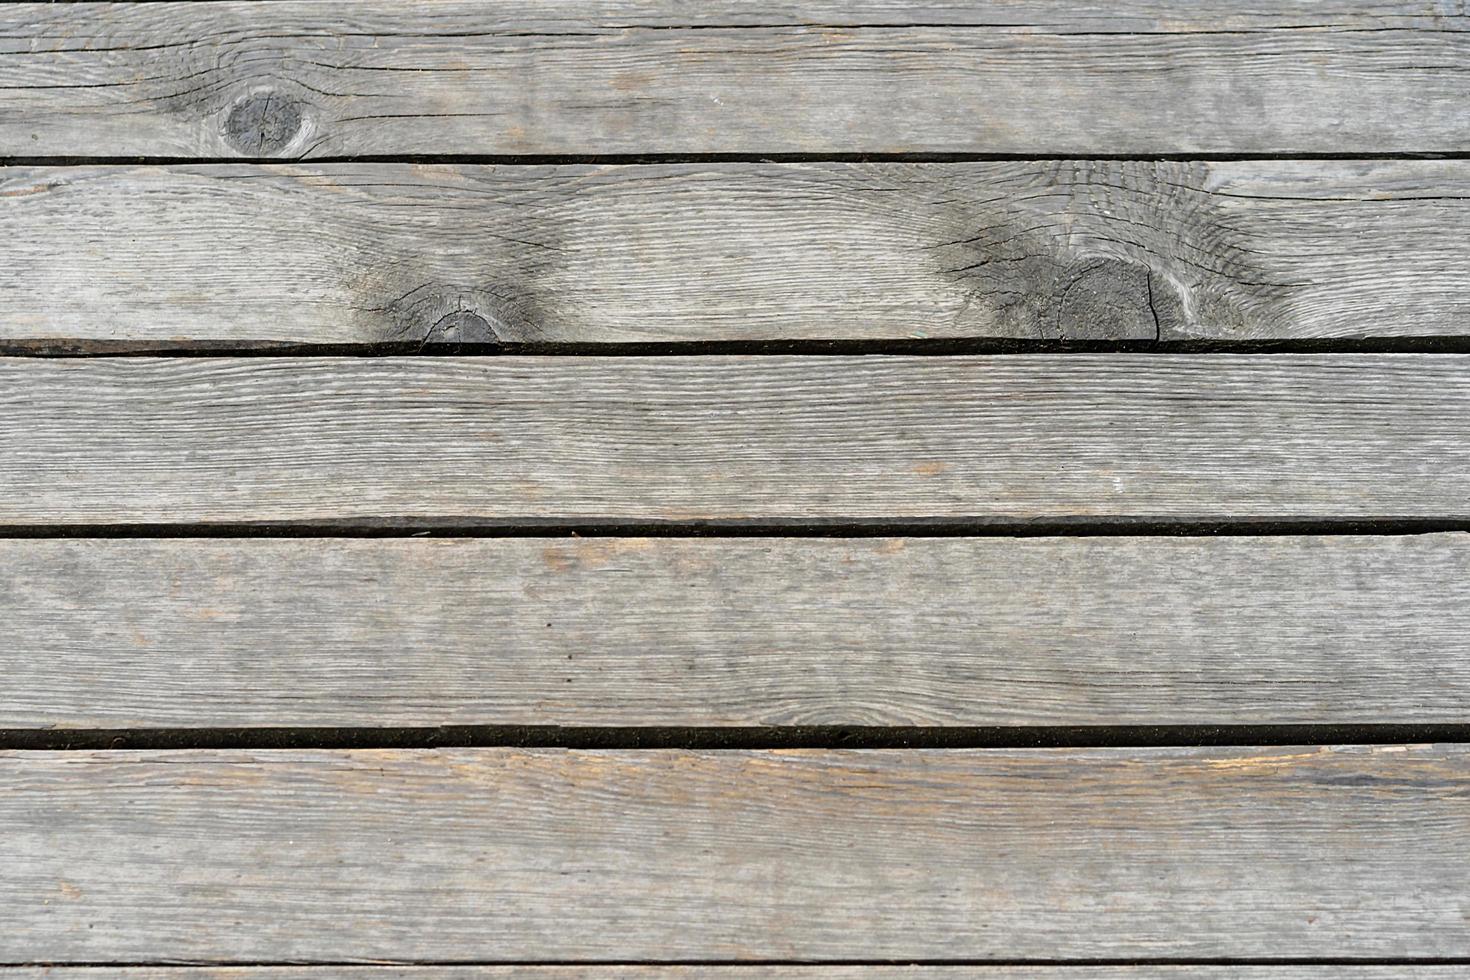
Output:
(14, 335), (1470, 359)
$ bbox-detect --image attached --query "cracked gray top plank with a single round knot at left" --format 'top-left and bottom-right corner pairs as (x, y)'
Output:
(0, 0), (1470, 157)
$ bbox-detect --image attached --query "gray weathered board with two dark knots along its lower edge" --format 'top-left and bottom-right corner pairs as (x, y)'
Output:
(0, 160), (1470, 345)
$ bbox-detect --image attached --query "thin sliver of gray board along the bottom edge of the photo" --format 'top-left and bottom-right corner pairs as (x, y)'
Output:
(0, 964), (1466, 980)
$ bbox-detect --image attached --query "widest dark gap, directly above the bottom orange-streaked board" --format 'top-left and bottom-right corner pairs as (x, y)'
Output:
(0, 723), (1470, 751)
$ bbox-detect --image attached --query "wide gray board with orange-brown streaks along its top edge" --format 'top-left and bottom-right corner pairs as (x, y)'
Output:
(0, 745), (1470, 964)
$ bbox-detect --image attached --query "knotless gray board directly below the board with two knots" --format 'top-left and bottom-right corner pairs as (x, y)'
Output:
(0, 354), (1470, 526)
